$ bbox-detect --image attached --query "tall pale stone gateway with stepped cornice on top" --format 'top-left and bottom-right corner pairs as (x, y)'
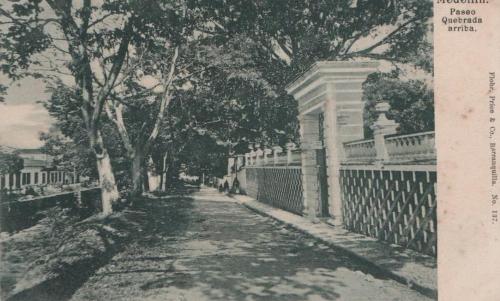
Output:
(286, 61), (378, 225)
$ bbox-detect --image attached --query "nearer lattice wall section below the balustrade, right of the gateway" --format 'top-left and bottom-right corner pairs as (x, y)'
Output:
(340, 169), (437, 256)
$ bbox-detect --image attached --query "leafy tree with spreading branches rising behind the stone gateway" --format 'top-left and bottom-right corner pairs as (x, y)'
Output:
(191, 0), (432, 144)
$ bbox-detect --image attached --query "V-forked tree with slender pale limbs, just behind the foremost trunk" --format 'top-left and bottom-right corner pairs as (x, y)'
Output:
(105, 45), (180, 195)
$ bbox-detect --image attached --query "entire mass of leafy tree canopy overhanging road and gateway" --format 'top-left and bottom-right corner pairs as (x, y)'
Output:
(0, 0), (433, 198)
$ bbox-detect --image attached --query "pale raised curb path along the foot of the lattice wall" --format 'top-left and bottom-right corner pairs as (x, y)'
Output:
(228, 194), (438, 299)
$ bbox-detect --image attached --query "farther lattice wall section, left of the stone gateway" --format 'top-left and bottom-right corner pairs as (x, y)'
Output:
(245, 167), (304, 214)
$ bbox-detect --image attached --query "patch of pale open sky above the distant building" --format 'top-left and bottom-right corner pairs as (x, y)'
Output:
(0, 74), (53, 148)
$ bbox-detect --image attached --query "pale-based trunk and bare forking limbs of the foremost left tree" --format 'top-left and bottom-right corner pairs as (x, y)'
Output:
(46, 0), (133, 214)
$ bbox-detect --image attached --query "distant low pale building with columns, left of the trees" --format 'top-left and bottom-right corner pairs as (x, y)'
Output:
(0, 147), (79, 189)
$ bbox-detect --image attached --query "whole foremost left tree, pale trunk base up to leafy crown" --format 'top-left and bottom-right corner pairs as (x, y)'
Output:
(0, 0), (189, 214)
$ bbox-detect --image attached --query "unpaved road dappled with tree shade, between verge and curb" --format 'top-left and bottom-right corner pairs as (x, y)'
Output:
(71, 192), (427, 301)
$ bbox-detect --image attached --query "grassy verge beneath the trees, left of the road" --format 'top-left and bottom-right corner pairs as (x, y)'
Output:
(0, 200), (145, 300)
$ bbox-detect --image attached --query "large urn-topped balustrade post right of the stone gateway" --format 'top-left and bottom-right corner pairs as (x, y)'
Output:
(370, 102), (399, 167)
